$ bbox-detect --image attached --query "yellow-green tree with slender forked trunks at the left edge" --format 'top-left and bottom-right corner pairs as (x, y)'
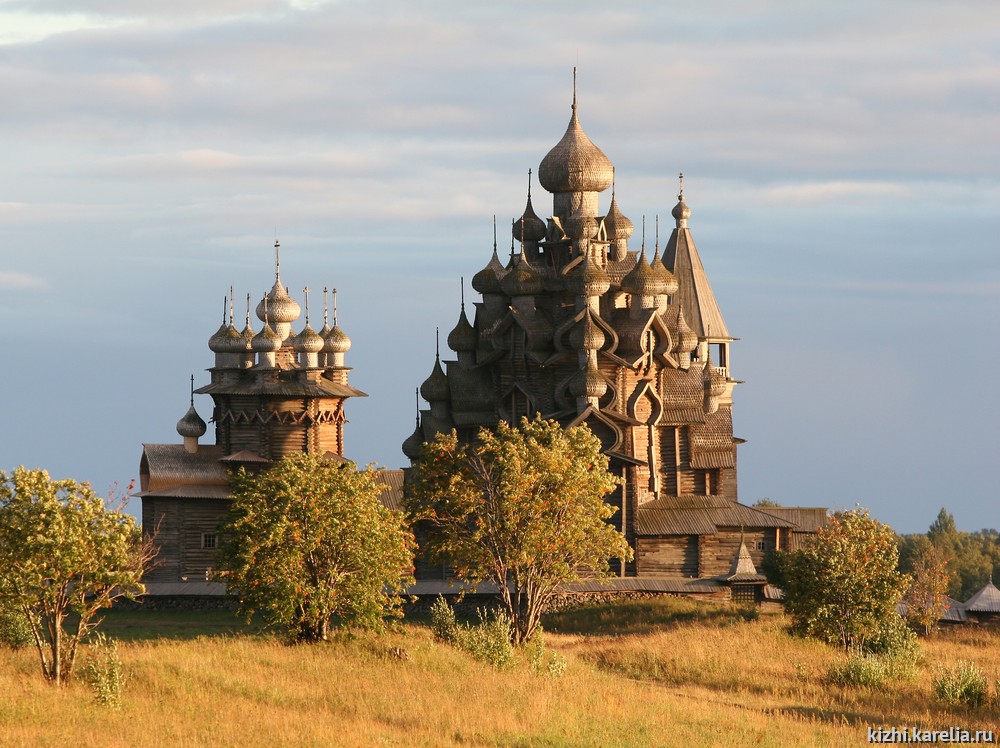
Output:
(0, 467), (155, 685)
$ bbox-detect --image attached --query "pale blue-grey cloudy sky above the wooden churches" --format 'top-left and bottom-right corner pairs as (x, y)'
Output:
(0, 0), (1000, 533)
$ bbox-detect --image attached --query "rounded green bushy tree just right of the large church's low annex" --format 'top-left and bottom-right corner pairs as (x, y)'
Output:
(784, 508), (908, 649)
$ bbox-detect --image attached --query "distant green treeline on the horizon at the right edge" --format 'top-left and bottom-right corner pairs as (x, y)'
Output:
(896, 507), (1000, 602)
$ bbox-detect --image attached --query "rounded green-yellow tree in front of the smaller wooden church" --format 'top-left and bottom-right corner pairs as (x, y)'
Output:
(219, 453), (413, 641)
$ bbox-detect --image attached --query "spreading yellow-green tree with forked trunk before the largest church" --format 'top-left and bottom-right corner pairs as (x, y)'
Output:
(407, 417), (632, 644)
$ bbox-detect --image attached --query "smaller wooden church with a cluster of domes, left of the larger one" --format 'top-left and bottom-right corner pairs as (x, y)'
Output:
(139, 242), (366, 594)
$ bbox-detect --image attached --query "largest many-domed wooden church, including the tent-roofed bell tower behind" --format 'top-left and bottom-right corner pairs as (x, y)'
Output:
(403, 83), (792, 578)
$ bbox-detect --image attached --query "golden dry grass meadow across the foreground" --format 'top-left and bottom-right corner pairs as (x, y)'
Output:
(0, 598), (1000, 747)
